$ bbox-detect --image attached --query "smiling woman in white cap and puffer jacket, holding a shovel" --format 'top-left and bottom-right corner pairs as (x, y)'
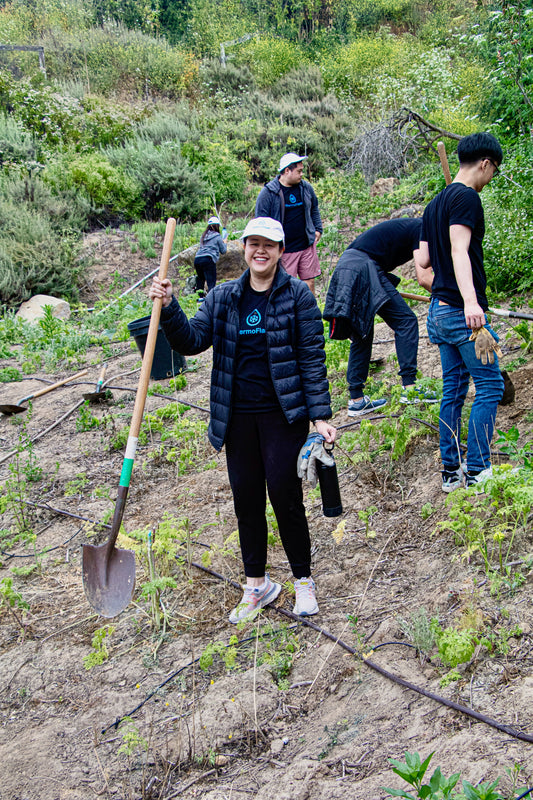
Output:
(150, 217), (336, 623)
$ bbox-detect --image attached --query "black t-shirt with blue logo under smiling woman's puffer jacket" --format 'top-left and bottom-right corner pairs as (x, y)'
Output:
(233, 285), (279, 413)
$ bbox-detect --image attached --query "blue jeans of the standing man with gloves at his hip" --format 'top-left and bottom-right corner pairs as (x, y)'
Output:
(427, 298), (503, 472)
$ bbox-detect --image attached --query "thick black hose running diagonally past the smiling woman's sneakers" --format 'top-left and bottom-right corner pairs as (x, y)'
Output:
(191, 561), (533, 744)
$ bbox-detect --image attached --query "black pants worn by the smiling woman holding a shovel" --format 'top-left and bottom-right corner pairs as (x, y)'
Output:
(226, 409), (311, 579)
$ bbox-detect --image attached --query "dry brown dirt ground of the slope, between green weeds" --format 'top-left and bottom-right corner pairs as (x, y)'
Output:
(0, 232), (533, 800)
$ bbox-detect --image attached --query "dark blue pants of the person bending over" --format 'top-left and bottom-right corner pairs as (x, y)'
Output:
(346, 270), (418, 398)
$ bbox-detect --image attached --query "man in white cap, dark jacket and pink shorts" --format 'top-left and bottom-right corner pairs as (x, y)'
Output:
(255, 153), (322, 294)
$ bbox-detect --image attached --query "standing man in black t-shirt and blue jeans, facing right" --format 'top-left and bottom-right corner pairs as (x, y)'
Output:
(420, 133), (504, 492)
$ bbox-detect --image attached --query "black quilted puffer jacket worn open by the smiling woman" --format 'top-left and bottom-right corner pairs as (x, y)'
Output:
(161, 267), (331, 450)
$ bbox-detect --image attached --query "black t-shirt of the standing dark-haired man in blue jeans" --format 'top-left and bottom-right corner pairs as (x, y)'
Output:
(420, 183), (489, 311)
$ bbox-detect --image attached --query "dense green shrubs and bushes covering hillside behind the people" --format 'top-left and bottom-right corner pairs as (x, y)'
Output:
(0, 0), (533, 307)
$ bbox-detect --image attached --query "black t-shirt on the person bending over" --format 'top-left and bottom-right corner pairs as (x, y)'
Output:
(348, 218), (422, 272)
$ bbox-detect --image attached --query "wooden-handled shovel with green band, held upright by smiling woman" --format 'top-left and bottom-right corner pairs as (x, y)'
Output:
(82, 217), (176, 617)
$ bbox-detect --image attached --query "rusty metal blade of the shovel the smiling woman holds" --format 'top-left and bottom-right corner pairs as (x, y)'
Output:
(82, 542), (135, 617)
